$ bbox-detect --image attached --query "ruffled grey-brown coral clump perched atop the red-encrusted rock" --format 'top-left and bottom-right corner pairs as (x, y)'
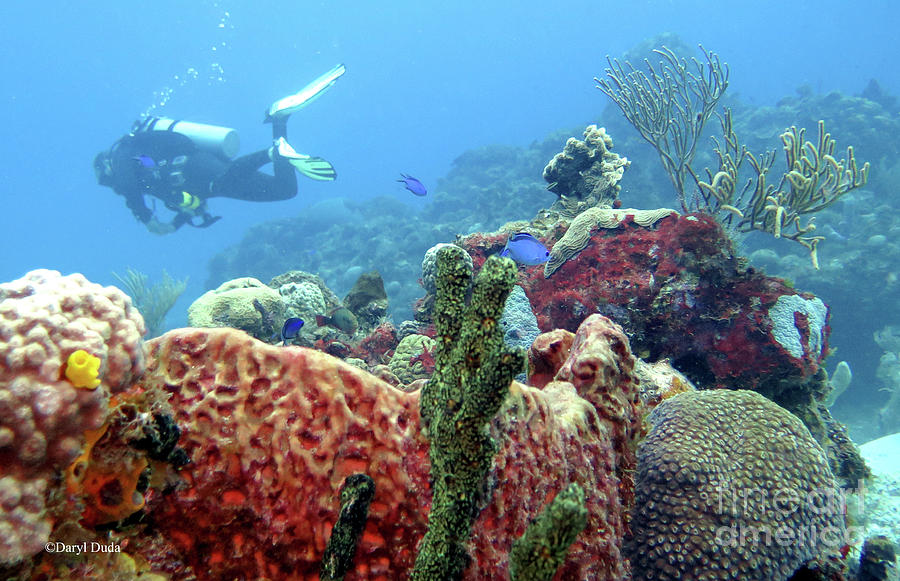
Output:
(543, 125), (631, 218)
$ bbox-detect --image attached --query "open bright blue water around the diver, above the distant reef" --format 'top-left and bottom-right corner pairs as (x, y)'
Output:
(0, 0), (900, 312)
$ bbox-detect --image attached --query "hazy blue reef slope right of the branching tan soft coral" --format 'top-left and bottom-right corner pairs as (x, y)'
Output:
(712, 86), (900, 430)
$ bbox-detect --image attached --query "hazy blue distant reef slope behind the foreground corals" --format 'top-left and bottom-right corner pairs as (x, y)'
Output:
(202, 64), (900, 444)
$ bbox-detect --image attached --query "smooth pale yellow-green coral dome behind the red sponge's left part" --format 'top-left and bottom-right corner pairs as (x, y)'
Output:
(188, 277), (285, 340)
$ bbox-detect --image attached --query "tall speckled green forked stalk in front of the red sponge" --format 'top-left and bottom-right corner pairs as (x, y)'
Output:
(410, 246), (525, 581)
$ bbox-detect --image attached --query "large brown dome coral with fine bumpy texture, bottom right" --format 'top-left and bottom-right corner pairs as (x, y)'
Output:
(630, 390), (846, 581)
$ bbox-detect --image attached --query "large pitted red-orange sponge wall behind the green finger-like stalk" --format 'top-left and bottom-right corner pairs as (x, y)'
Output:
(138, 320), (637, 580)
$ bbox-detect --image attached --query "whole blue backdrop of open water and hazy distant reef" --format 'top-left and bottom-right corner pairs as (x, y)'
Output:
(0, 0), (900, 448)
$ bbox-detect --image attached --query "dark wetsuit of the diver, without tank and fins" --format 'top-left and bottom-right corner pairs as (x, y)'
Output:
(105, 120), (297, 229)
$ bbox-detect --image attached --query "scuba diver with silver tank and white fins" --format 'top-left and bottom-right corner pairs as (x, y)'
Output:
(94, 65), (345, 234)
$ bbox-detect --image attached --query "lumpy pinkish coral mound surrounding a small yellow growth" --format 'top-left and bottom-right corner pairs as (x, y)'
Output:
(0, 270), (145, 564)
